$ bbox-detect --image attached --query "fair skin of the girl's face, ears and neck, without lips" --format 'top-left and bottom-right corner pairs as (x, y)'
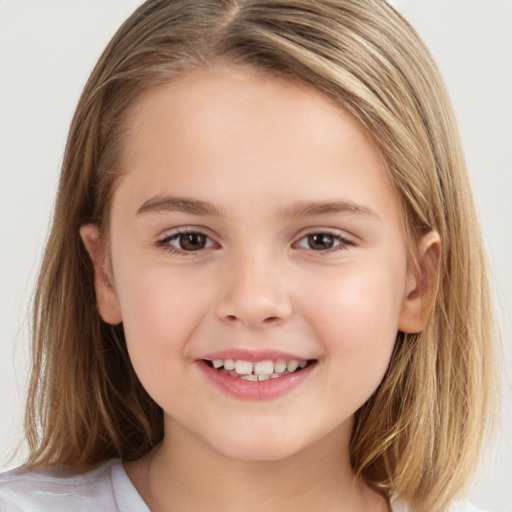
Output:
(81, 67), (438, 511)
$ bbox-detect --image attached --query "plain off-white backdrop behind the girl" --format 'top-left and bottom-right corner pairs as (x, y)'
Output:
(0, 0), (512, 512)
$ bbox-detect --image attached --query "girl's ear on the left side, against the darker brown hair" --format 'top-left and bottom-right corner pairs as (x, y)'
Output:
(80, 224), (122, 325)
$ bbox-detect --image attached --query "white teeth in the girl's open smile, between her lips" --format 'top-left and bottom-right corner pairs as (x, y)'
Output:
(202, 359), (317, 382)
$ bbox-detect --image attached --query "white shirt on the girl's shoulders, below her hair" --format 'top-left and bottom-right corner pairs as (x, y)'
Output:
(0, 459), (483, 512)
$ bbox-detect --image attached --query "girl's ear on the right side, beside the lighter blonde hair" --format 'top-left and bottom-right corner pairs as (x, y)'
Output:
(398, 231), (441, 334)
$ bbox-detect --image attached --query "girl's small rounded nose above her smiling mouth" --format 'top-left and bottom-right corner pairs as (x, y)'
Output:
(216, 252), (292, 328)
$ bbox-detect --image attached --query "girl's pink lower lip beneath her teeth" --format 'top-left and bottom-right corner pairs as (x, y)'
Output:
(198, 361), (316, 400)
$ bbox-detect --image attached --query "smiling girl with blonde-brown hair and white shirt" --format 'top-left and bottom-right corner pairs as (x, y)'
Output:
(0, 0), (495, 512)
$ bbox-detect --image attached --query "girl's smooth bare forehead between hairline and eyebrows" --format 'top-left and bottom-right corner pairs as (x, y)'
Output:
(115, 66), (394, 222)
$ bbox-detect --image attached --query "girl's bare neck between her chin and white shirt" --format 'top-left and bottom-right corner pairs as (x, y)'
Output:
(125, 416), (389, 512)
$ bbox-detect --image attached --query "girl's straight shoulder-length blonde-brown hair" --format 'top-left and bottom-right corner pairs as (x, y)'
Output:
(25, 0), (496, 512)
